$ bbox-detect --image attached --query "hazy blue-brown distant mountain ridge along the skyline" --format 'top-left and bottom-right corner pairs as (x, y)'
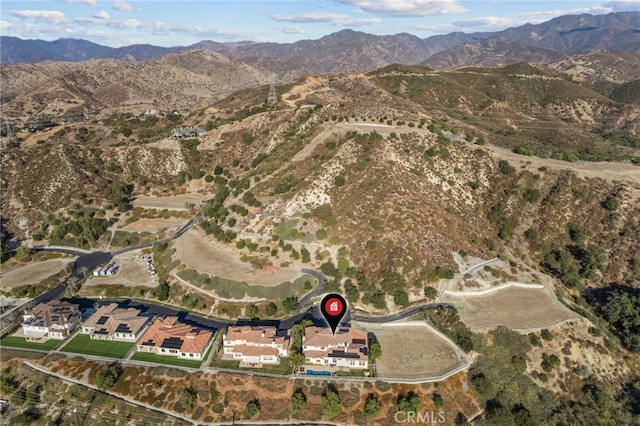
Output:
(0, 12), (640, 73)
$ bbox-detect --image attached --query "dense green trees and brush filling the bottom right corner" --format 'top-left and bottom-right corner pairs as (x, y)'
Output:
(469, 327), (640, 425)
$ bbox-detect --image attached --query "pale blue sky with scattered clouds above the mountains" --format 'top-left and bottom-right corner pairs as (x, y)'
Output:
(0, 0), (640, 47)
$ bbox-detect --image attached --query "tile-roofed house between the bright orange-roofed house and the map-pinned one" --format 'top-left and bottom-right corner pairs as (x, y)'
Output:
(222, 325), (290, 367)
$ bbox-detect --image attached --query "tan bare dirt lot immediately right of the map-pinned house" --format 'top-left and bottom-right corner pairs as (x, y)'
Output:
(352, 321), (465, 379)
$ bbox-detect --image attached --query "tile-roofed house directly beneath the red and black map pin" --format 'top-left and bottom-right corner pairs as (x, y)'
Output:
(302, 326), (369, 370)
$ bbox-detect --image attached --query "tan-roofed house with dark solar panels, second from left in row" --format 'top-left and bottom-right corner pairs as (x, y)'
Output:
(81, 303), (149, 342)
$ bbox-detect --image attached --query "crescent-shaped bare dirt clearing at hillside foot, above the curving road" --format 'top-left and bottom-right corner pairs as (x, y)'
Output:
(175, 230), (303, 287)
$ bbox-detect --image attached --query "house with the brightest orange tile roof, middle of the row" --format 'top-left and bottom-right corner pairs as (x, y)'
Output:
(136, 316), (213, 360)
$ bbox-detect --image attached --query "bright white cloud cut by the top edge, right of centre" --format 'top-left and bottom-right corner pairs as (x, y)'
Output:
(335, 0), (467, 17)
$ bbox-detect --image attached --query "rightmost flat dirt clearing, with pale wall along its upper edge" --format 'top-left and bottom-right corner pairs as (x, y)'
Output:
(443, 287), (579, 330)
